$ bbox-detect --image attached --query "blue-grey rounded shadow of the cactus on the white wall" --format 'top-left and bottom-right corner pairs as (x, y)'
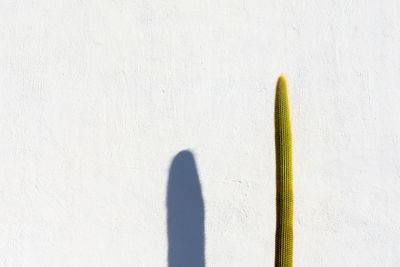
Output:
(167, 150), (205, 267)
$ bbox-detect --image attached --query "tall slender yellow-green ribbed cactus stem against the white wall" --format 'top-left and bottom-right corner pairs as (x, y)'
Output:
(275, 75), (293, 267)
